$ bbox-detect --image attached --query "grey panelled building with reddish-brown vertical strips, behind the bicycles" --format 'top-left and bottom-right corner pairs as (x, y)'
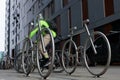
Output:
(5, 0), (120, 57)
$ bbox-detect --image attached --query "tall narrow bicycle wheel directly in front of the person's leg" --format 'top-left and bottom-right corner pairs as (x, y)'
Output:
(37, 28), (55, 79)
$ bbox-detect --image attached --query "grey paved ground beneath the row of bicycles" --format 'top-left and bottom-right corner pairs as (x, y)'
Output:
(0, 66), (120, 80)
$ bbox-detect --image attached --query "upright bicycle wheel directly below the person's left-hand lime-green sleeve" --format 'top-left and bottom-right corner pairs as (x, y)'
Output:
(22, 38), (33, 76)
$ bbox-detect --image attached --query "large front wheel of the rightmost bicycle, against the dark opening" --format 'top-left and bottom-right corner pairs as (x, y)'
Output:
(84, 31), (111, 77)
